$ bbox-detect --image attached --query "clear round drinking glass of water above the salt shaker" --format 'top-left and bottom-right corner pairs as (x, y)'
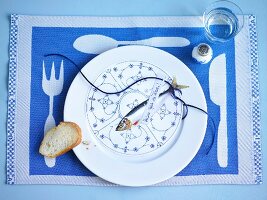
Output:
(203, 0), (244, 42)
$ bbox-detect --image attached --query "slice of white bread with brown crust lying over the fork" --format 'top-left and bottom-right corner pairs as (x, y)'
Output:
(39, 122), (82, 158)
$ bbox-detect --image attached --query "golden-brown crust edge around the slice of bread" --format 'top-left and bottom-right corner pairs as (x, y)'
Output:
(39, 122), (82, 158)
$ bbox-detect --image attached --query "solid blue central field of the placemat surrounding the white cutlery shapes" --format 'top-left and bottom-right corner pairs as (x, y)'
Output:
(29, 27), (238, 176)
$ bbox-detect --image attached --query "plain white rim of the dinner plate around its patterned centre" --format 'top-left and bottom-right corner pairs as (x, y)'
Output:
(64, 45), (207, 186)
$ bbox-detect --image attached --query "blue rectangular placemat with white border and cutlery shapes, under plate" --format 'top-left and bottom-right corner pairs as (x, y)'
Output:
(7, 15), (262, 185)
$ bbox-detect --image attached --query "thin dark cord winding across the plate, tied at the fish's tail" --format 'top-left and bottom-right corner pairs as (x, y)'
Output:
(44, 53), (216, 155)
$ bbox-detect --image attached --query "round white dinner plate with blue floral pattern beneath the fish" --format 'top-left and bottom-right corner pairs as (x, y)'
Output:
(64, 45), (207, 186)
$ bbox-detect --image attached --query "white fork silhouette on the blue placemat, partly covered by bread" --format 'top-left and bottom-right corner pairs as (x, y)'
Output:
(42, 60), (64, 167)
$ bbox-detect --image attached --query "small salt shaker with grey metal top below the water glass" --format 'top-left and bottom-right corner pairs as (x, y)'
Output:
(192, 43), (213, 64)
